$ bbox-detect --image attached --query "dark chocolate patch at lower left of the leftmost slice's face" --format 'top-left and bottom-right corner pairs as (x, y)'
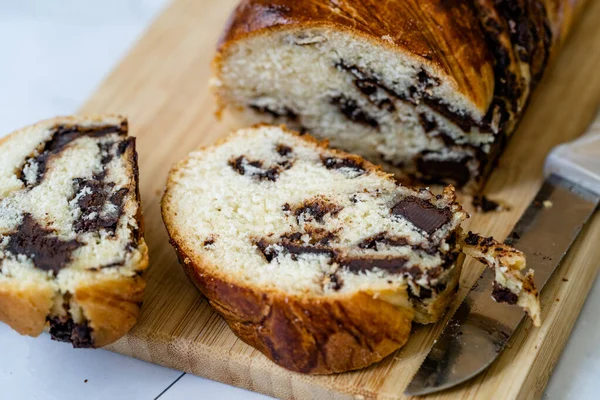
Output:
(4, 214), (82, 274)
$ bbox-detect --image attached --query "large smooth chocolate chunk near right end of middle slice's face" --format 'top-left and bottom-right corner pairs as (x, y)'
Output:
(392, 196), (452, 235)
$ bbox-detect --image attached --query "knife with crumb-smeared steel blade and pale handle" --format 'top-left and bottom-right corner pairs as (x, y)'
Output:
(404, 113), (600, 396)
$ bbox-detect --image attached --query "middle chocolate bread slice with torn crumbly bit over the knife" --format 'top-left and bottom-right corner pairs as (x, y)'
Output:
(162, 126), (539, 374)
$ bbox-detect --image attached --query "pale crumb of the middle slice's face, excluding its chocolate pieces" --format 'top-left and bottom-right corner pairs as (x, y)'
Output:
(163, 126), (466, 306)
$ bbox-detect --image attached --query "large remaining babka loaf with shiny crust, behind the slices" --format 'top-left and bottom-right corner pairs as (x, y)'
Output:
(212, 0), (584, 192)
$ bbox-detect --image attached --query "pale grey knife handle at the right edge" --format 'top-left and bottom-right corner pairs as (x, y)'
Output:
(544, 113), (600, 195)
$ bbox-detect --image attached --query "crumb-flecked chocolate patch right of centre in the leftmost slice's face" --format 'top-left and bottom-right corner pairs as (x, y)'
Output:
(73, 174), (129, 233)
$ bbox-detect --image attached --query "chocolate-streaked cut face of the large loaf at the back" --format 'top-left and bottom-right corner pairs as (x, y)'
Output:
(212, 28), (495, 191)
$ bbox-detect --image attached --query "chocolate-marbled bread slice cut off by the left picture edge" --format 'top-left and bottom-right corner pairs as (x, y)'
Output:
(0, 116), (148, 347)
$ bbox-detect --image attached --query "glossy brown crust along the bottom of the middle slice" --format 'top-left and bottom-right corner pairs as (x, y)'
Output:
(165, 234), (413, 374)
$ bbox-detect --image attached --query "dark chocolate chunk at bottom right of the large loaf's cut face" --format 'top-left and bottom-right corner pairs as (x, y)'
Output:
(416, 152), (471, 187)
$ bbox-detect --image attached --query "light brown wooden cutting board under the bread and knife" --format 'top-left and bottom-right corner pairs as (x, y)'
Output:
(81, 0), (600, 399)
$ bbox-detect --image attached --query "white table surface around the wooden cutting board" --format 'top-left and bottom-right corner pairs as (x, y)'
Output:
(0, 0), (600, 400)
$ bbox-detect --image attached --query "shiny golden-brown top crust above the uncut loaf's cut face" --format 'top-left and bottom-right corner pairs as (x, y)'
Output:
(215, 0), (494, 113)
